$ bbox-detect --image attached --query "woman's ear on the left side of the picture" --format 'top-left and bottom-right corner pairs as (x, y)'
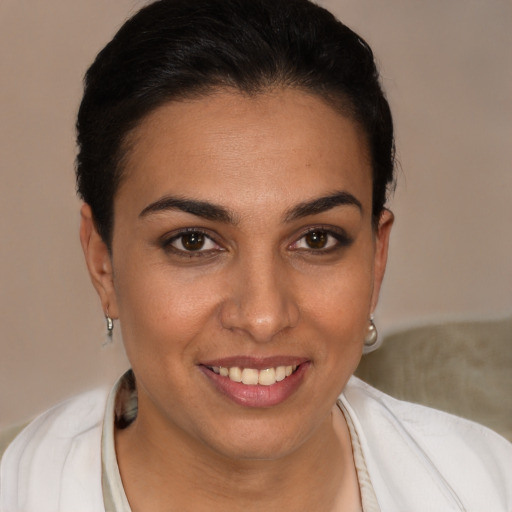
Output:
(80, 204), (119, 318)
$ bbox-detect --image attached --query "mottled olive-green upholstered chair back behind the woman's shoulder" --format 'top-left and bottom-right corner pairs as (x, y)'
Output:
(356, 317), (512, 441)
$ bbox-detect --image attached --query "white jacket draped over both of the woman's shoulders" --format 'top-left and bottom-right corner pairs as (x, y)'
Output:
(0, 377), (512, 512)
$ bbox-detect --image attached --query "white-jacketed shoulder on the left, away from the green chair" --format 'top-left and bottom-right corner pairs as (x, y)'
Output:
(0, 389), (108, 511)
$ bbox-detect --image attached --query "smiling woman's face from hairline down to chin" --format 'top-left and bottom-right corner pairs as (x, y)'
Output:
(82, 89), (392, 459)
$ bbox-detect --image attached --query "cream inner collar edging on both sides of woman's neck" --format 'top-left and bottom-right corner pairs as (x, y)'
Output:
(101, 374), (380, 512)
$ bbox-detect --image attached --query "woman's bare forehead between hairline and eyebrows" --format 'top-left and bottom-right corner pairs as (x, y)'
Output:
(116, 89), (372, 214)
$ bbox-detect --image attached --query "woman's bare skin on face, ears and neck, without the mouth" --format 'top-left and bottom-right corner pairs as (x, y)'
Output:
(81, 89), (393, 511)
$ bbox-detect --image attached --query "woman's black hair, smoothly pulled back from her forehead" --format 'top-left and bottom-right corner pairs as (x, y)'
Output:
(76, 0), (394, 247)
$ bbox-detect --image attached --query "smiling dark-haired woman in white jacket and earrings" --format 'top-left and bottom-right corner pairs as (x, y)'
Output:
(0, 0), (512, 512)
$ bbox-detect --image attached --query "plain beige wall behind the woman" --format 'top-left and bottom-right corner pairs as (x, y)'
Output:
(0, 0), (512, 427)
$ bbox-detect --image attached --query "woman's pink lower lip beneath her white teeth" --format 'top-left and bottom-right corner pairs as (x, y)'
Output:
(199, 363), (309, 407)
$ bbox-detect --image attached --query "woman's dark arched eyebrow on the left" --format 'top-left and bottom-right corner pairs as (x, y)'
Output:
(139, 196), (237, 224)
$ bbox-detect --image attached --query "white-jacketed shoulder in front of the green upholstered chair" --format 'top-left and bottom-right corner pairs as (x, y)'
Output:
(341, 378), (512, 511)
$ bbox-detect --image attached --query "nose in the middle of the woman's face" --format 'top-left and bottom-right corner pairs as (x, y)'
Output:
(221, 260), (300, 343)
